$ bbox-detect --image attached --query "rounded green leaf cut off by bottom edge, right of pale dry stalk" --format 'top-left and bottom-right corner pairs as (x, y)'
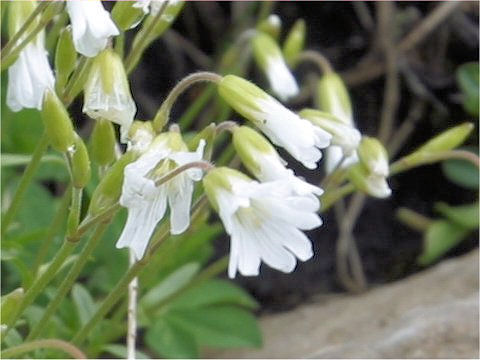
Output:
(145, 318), (198, 359)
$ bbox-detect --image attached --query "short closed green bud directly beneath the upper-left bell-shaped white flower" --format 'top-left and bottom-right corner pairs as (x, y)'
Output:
(90, 119), (117, 166)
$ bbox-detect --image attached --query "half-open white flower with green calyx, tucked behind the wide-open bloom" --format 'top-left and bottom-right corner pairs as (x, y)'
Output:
(232, 126), (323, 201)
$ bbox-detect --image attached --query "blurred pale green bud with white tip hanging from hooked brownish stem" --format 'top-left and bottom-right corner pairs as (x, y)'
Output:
(317, 72), (353, 125)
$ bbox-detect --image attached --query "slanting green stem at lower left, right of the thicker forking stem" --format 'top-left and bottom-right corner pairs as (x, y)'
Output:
(26, 223), (108, 341)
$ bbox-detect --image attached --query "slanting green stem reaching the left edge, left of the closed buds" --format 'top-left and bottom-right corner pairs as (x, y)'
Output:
(1, 133), (49, 238)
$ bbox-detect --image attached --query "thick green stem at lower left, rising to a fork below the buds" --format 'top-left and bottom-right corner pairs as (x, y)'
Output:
(6, 241), (77, 329)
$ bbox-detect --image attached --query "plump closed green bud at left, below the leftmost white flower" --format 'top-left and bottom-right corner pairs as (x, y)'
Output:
(42, 90), (75, 152)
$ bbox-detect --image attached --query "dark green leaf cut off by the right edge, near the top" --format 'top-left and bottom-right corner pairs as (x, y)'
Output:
(457, 62), (480, 116)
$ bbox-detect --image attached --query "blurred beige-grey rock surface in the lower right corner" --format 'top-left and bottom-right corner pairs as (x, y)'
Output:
(212, 250), (479, 358)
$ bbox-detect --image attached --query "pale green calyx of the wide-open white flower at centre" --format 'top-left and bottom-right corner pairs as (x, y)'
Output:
(202, 166), (251, 211)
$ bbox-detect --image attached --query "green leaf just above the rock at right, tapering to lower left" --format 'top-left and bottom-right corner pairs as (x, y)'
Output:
(417, 220), (469, 265)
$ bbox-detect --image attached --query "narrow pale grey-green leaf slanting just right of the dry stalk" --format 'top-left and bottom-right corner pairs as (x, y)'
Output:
(140, 263), (200, 307)
